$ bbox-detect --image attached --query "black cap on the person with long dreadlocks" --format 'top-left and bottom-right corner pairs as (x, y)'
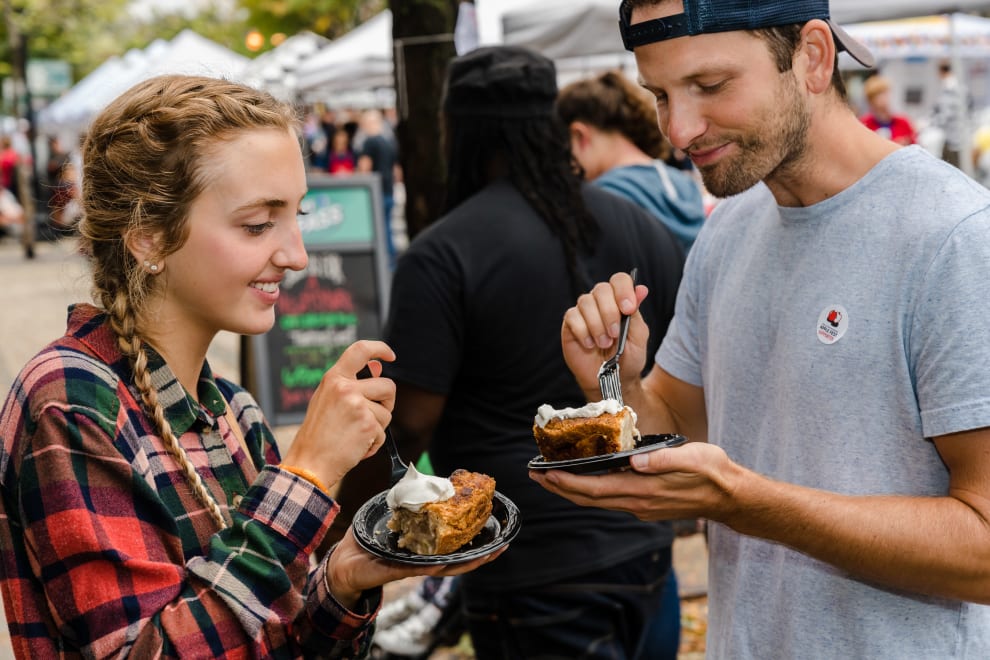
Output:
(443, 46), (557, 119)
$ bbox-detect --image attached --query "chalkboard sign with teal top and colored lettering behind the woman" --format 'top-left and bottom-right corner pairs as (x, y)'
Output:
(241, 174), (390, 426)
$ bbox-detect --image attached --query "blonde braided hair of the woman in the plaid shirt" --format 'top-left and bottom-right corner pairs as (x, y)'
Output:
(79, 75), (299, 528)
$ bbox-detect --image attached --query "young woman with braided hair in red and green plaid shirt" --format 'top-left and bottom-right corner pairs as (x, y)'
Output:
(0, 76), (500, 657)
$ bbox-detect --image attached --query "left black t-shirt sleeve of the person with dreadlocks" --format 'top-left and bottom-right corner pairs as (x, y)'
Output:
(385, 243), (465, 394)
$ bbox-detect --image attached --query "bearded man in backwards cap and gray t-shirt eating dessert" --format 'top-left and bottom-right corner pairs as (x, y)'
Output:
(530, 0), (990, 660)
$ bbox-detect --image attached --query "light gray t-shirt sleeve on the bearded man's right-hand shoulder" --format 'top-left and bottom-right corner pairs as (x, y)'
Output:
(910, 210), (990, 437)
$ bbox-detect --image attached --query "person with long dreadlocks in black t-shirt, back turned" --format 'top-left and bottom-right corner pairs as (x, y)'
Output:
(330, 46), (683, 660)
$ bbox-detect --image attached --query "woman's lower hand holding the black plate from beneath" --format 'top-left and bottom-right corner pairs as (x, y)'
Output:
(327, 528), (508, 609)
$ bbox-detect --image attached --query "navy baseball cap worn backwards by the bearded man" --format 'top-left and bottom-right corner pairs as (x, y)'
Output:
(619, 0), (874, 68)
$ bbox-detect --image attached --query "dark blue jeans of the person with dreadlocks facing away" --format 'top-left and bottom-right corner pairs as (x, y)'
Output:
(463, 548), (671, 660)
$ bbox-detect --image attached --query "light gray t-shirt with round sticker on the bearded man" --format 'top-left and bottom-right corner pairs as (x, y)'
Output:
(657, 147), (990, 660)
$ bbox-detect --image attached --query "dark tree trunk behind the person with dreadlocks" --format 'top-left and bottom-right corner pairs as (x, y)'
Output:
(389, 0), (458, 239)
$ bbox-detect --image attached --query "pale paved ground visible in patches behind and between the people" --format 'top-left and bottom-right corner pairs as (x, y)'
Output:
(0, 238), (707, 660)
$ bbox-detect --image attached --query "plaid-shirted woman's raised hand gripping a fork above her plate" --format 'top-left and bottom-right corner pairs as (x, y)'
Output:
(283, 340), (395, 487)
